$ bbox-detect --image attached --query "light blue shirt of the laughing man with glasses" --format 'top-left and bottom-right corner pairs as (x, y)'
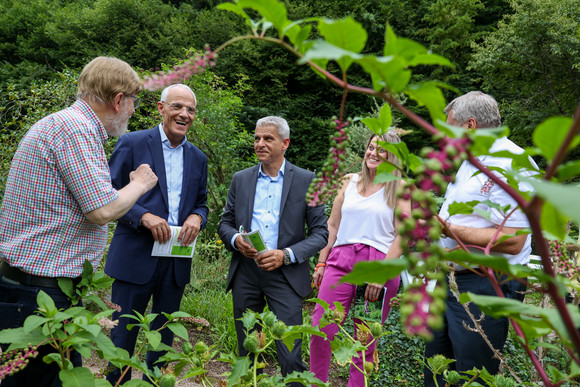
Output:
(159, 124), (187, 226)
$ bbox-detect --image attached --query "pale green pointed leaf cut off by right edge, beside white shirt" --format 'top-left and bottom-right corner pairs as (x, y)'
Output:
(526, 178), (580, 223)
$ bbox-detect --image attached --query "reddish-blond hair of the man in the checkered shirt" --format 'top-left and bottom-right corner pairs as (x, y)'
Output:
(77, 56), (143, 103)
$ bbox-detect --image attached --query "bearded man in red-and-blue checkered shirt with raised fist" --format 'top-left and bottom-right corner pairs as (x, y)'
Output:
(0, 57), (157, 387)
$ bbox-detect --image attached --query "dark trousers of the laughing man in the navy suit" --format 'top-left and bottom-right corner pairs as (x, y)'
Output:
(107, 258), (185, 385)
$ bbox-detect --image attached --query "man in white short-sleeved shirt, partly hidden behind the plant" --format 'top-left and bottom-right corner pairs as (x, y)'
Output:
(425, 91), (537, 387)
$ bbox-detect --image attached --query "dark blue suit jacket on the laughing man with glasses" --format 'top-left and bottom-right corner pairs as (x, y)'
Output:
(105, 126), (208, 286)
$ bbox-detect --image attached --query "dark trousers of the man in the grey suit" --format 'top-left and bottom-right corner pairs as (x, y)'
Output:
(232, 258), (306, 386)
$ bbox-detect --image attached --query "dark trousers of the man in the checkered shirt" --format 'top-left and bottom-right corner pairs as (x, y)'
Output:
(0, 275), (82, 387)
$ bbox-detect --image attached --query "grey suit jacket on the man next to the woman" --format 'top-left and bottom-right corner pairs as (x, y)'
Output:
(218, 161), (328, 297)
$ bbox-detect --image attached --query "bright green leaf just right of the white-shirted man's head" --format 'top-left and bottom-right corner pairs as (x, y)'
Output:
(532, 117), (574, 162)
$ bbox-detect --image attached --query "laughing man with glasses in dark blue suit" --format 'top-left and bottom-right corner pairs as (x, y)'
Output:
(105, 84), (208, 382)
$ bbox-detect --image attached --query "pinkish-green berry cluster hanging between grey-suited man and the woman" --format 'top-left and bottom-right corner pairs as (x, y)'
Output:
(306, 119), (349, 206)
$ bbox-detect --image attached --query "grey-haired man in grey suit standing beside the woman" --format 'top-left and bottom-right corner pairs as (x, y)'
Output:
(218, 117), (328, 385)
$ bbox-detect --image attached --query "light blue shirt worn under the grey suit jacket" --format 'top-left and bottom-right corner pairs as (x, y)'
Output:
(231, 159), (296, 262)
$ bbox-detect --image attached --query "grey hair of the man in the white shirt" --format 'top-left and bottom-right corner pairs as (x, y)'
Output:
(445, 91), (501, 129)
